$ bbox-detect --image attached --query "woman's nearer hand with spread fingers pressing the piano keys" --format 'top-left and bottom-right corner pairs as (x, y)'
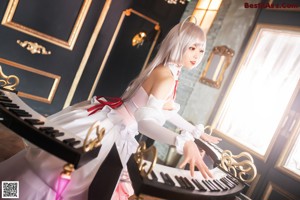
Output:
(179, 141), (213, 179)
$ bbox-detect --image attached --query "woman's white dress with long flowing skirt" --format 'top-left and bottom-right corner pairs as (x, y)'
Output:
(0, 65), (183, 200)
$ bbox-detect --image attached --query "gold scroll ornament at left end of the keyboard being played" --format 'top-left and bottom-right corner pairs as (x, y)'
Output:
(134, 142), (157, 177)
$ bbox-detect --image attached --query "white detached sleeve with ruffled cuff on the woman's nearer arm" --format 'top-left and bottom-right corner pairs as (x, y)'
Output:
(134, 95), (193, 154)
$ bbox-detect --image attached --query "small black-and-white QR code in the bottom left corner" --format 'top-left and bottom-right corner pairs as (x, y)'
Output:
(2, 181), (19, 199)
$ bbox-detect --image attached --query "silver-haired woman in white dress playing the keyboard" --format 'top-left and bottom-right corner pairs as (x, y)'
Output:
(0, 22), (220, 200)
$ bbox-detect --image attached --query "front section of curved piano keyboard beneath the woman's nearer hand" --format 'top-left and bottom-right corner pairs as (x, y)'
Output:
(127, 158), (245, 200)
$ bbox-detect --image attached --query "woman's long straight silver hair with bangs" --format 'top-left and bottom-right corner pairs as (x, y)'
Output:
(122, 21), (206, 101)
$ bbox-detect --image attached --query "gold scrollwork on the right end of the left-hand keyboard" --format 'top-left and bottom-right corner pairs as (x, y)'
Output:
(83, 121), (105, 152)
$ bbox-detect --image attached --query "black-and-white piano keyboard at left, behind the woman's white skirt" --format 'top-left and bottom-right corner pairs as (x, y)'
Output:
(0, 89), (100, 168)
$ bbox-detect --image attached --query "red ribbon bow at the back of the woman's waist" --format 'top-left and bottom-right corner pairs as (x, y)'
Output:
(87, 96), (123, 116)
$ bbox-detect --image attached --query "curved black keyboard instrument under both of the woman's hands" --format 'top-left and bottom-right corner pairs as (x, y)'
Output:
(127, 134), (253, 200)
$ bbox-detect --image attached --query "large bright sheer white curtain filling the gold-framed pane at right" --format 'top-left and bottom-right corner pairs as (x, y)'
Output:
(213, 25), (300, 156)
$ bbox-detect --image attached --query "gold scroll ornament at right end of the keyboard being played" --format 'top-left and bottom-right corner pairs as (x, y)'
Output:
(220, 150), (257, 183)
